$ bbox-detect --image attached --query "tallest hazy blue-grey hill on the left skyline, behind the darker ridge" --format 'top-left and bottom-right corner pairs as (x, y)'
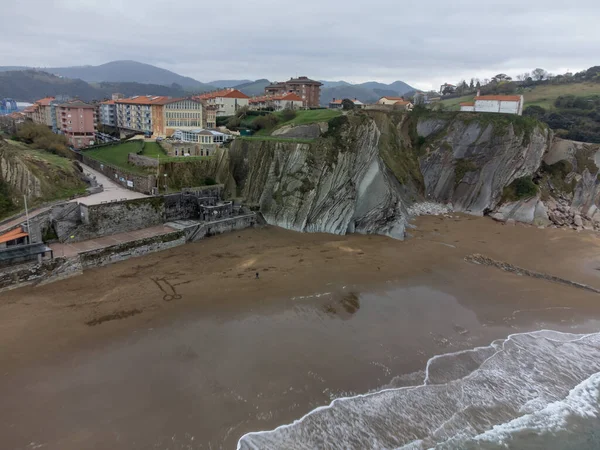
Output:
(0, 61), (214, 92)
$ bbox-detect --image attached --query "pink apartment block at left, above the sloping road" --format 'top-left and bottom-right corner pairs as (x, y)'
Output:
(56, 100), (97, 148)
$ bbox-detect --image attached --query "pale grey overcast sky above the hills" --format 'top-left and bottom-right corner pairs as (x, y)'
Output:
(0, 0), (600, 89)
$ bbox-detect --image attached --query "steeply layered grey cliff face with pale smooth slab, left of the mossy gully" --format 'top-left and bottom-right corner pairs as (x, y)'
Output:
(225, 116), (408, 238)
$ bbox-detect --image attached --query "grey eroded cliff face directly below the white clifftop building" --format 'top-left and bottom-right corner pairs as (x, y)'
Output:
(417, 114), (551, 215)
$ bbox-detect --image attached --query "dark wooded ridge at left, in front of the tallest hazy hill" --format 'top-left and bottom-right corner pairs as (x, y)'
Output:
(0, 70), (188, 102)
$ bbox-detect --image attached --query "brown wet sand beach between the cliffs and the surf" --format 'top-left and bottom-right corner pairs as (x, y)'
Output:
(0, 216), (600, 449)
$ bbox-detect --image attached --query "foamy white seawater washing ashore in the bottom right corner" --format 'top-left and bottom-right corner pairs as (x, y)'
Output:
(237, 331), (600, 450)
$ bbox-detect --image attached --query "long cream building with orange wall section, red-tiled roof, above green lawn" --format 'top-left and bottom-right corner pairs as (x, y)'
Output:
(114, 95), (203, 137)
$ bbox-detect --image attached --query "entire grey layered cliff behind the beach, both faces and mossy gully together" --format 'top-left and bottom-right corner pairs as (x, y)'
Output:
(217, 111), (564, 238)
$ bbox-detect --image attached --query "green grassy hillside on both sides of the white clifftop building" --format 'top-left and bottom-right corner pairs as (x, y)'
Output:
(441, 83), (600, 111)
